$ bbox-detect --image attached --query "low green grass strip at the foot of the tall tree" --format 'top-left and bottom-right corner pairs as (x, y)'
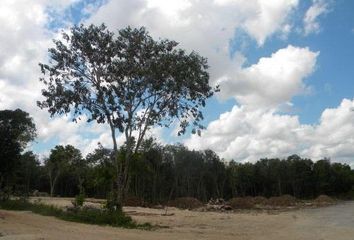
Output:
(0, 199), (152, 230)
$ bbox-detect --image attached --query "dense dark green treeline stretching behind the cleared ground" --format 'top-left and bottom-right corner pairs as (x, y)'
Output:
(6, 139), (354, 204)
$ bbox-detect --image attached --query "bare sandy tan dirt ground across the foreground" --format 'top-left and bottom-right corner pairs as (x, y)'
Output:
(0, 198), (354, 240)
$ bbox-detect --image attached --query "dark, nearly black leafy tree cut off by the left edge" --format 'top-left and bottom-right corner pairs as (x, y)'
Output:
(0, 109), (36, 190)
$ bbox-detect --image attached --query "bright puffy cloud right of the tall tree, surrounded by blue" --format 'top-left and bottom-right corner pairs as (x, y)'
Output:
(219, 45), (319, 108)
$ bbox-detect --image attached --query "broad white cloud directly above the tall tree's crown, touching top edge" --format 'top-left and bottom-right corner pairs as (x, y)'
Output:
(86, 0), (298, 86)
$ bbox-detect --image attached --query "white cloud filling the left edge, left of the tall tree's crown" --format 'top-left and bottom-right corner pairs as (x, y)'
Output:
(0, 0), (102, 157)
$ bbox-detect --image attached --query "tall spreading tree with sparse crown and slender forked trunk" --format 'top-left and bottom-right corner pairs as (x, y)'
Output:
(38, 25), (214, 207)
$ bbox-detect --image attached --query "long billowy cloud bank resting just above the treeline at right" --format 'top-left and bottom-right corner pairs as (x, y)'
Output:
(185, 99), (354, 166)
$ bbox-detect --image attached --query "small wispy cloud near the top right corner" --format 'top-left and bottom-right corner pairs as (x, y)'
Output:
(303, 0), (329, 35)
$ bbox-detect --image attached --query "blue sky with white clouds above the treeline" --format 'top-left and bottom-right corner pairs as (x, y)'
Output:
(0, 0), (354, 167)
